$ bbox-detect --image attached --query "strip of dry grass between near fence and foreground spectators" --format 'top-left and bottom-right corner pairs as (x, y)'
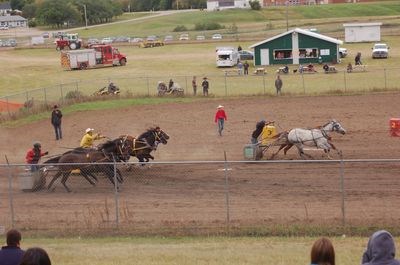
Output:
(22, 237), (368, 265)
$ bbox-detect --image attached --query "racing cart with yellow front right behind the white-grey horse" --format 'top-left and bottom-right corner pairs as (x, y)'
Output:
(243, 123), (287, 160)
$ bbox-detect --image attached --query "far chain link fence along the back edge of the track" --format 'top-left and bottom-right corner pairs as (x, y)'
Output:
(0, 68), (400, 117)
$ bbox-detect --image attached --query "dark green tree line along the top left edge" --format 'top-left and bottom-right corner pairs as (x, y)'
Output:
(4, 0), (207, 28)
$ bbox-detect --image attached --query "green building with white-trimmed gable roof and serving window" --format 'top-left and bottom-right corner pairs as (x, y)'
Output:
(250, 28), (343, 65)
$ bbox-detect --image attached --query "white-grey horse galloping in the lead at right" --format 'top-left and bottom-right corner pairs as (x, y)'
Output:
(272, 120), (346, 159)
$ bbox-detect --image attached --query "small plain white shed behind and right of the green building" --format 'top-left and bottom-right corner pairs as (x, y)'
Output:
(343, 22), (382, 42)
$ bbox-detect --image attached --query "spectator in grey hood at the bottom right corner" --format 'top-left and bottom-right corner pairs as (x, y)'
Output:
(361, 230), (400, 265)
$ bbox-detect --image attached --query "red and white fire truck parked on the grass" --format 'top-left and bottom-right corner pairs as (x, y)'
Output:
(61, 45), (126, 70)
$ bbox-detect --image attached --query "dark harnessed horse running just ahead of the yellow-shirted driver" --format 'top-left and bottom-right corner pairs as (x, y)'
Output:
(120, 127), (169, 163)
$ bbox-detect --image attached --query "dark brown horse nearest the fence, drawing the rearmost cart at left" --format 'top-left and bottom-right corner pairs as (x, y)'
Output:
(44, 138), (131, 192)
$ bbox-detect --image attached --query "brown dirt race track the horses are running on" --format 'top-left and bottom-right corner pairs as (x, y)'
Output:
(0, 93), (400, 229)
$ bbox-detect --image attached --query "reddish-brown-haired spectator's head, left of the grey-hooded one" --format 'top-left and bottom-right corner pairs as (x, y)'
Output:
(311, 237), (335, 265)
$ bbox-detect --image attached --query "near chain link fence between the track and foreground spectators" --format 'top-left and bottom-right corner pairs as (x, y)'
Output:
(0, 159), (400, 234)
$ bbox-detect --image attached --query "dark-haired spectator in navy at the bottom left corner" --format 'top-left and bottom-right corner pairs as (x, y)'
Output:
(0, 229), (25, 265)
